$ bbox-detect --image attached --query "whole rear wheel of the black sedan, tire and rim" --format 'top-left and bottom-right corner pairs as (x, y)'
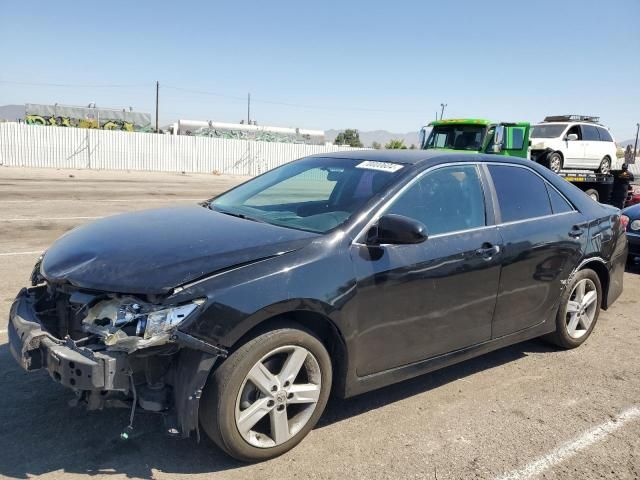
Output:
(547, 268), (602, 349)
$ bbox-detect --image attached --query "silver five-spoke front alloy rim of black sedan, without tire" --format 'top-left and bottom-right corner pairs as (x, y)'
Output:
(235, 345), (322, 448)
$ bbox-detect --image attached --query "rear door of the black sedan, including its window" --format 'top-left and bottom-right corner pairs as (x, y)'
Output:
(488, 164), (588, 338)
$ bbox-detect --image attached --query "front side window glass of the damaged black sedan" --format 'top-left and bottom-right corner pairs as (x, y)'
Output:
(385, 165), (486, 235)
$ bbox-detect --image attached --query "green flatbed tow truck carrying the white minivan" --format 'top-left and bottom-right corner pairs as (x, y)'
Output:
(419, 118), (629, 208)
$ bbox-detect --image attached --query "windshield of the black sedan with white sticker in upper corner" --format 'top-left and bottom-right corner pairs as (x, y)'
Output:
(209, 157), (404, 233)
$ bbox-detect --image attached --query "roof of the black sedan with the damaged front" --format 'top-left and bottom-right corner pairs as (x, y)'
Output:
(306, 149), (535, 166)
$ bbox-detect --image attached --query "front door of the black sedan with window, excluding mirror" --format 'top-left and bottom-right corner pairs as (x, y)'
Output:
(351, 164), (501, 376)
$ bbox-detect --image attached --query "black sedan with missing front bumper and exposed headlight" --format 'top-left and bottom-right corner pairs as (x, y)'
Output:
(9, 151), (627, 461)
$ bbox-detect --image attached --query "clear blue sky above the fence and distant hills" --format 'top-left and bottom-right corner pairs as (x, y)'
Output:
(0, 0), (640, 140)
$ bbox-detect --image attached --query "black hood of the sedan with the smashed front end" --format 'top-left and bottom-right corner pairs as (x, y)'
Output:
(41, 206), (318, 294)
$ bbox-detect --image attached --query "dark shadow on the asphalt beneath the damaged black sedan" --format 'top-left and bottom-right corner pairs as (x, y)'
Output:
(0, 341), (554, 478)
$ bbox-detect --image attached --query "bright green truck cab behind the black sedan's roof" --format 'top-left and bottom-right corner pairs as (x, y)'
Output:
(420, 118), (531, 158)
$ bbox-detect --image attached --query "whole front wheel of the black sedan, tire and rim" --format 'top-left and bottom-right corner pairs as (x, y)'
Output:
(200, 327), (332, 462)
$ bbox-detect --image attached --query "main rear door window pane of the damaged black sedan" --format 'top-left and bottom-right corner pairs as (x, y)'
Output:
(489, 165), (552, 222)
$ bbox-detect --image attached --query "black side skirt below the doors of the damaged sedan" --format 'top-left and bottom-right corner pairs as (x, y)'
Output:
(344, 316), (555, 397)
